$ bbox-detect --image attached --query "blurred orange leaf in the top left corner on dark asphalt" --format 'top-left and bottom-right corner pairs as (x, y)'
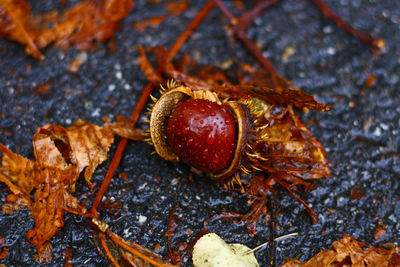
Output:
(0, 0), (134, 59)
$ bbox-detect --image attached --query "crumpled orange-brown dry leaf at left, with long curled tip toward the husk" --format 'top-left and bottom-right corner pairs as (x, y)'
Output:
(0, 120), (143, 262)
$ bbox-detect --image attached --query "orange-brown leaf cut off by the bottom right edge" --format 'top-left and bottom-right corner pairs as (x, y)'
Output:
(281, 236), (400, 267)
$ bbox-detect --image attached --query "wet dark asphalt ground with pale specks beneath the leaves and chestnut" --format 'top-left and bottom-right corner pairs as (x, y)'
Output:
(0, 0), (400, 266)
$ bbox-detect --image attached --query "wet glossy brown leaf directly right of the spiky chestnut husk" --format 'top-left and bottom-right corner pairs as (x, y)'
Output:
(252, 103), (329, 181)
